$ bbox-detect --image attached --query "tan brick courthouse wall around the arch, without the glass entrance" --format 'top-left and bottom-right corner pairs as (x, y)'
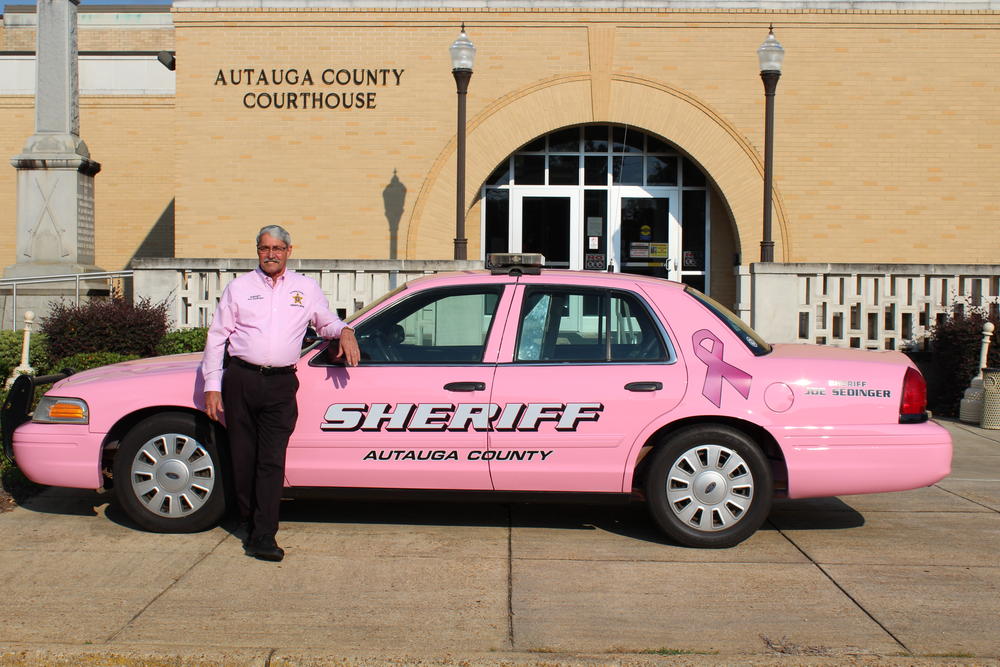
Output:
(0, 9), (1000, 274)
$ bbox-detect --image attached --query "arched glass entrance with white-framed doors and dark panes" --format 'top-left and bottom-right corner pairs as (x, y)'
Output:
(481, 124), (713, 291)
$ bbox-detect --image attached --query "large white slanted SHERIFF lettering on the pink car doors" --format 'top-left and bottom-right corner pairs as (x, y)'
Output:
(320, 403), (604, 431)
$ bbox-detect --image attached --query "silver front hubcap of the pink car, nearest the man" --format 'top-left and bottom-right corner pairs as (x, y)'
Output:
(131, 433), (216, 519)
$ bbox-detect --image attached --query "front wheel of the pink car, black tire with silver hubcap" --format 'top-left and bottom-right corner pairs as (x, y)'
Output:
(114, 412), (226, 533)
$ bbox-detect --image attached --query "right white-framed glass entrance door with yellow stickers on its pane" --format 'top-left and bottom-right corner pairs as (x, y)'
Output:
(612, 188), (681, 280)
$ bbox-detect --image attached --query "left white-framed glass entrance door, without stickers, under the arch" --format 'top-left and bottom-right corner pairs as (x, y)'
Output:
(510, 188), (583, 269)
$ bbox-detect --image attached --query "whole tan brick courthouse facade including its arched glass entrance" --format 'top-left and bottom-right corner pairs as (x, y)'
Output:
(0, 0), (1000, 310)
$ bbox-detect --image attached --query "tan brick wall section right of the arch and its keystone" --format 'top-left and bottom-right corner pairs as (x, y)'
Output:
(618, 12), (1000, 263)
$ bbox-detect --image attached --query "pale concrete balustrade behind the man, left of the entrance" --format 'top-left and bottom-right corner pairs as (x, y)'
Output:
(131, 258), (483, 329)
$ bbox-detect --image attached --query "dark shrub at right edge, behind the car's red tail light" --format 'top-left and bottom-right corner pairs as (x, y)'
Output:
(928, 308), (1000, 417)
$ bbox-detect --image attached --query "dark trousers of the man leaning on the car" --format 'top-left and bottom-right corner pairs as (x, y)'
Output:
(222, 363), (299, 539)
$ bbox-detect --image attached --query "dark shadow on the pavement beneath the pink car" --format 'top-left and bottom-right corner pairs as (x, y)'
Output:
(11, 488), (865, 546)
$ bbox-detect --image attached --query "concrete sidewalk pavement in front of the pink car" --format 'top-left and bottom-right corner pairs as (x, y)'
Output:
(0, 422), (1000, 665)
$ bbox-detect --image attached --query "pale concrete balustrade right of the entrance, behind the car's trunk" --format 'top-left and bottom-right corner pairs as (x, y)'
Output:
(738, 263), (1000, 350)
